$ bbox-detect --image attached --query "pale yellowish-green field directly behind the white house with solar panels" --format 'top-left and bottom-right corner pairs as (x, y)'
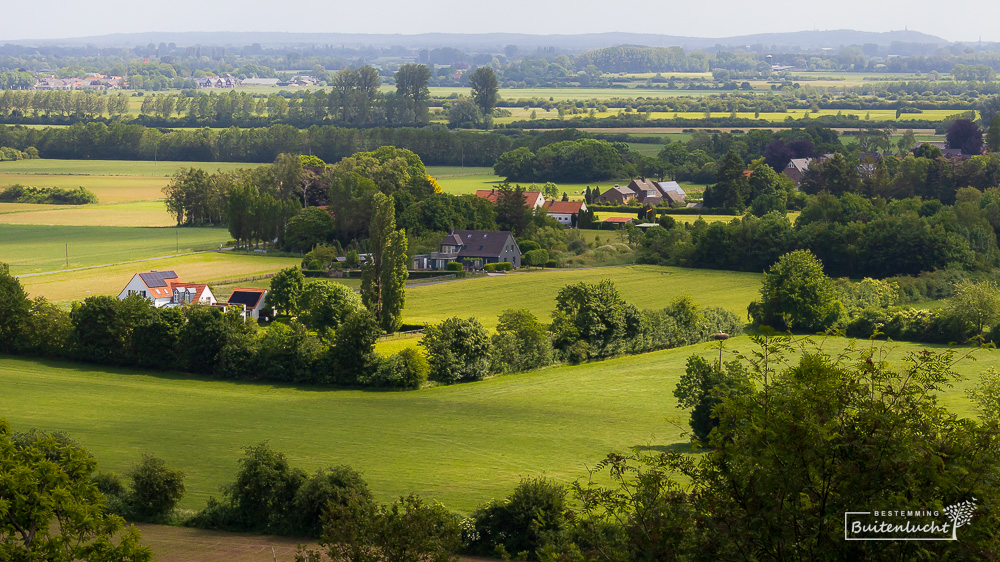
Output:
(21, 252), (302, 303)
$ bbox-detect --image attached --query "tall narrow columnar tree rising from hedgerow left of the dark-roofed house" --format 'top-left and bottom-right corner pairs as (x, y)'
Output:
(361, 193), (409, 332)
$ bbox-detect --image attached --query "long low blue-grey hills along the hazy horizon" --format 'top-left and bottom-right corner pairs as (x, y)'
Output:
(13, 29), (950, 52)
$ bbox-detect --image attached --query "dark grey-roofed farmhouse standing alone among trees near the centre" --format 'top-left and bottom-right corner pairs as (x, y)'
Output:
(413, 230), (521, 270)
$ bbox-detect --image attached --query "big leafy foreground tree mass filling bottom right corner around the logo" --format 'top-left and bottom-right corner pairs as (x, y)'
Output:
(573, 338), (1000, 561)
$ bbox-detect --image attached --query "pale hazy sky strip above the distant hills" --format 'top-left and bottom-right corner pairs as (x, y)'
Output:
(0, 0), (1000, 41)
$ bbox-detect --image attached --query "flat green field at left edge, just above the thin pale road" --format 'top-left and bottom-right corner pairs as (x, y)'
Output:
(0, 224), (230, 275)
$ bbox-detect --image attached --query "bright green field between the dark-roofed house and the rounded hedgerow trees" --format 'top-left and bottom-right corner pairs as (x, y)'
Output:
(403, 262), (763, 328)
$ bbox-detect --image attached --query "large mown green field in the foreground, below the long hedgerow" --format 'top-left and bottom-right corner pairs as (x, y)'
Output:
(0, 337), (984, 512)
